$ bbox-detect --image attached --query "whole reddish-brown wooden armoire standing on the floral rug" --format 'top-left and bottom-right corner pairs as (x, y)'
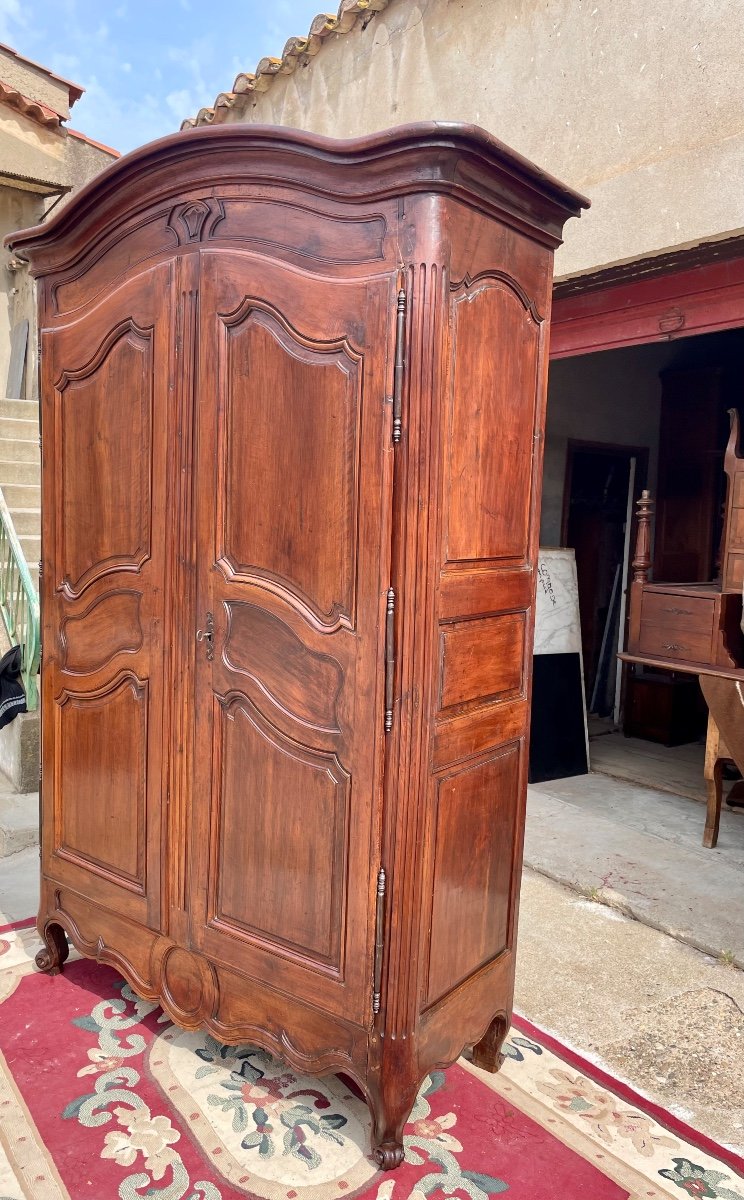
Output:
(11, 124), (586, 1168)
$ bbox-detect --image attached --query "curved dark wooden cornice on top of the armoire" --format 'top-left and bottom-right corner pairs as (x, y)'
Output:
(5, 121), (589, 275)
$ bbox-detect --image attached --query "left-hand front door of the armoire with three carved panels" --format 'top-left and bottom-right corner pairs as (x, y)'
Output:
(42, 264), (170, 928)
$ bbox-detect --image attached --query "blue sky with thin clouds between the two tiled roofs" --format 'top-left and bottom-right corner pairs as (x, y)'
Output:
(0, 0), (328, 154)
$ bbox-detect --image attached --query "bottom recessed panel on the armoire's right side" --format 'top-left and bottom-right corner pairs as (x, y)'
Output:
(426, 745), (520, 1004)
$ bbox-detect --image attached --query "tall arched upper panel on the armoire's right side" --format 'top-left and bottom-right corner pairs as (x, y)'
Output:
(444, 278), (539, 563)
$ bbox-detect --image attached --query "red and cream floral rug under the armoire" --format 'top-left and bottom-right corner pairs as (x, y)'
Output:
(0, 929), (744, 1200)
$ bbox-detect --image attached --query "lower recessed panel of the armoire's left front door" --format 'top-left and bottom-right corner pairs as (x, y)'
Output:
(55, 676), (148, 894)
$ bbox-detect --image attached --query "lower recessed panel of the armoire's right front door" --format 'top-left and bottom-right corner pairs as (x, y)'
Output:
(211, 700), (349, 971)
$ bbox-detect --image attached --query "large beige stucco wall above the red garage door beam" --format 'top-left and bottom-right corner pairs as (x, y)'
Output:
(226, 0), (744, 277)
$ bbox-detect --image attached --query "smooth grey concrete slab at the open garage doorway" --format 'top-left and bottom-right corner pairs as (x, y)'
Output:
(524, 774), (744, 968)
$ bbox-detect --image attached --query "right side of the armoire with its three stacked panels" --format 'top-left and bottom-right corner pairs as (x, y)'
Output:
(421, 231), (545, 1012)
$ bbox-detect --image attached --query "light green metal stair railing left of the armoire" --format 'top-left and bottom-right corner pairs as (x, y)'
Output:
(0, 492), (41, 712)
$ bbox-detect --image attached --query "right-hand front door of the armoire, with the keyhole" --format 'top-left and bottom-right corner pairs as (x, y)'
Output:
(188, 251), (394, 1022)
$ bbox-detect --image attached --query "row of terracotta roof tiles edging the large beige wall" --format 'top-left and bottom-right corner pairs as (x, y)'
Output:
(181, 0), (390, 130)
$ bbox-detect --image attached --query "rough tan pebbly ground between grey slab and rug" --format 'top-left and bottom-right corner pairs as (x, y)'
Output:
(515, 869), (744, 1153)
